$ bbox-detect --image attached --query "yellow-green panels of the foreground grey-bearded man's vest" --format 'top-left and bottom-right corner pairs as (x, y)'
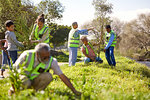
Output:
(25, 52), (53, 80)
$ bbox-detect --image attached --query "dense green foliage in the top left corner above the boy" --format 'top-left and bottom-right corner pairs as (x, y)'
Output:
(0, 0), (37, 31)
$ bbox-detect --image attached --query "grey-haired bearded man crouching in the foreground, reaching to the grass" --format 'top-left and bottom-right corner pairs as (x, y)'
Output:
(9, 43), (81, 95)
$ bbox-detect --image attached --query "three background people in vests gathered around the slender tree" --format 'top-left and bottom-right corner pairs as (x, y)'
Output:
(68, 22), (117, 66)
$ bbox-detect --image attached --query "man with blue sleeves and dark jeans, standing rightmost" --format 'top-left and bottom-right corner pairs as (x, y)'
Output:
(104, 25), (117, 66)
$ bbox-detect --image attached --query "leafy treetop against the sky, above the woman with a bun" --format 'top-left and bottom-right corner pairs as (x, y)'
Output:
(38, 0), (64, 23)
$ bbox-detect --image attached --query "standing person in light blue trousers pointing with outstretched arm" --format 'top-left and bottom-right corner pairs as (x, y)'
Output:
(68, 22), (93, 66)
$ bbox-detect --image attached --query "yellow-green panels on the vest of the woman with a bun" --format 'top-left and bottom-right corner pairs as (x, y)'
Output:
(34, 24), (50, 43)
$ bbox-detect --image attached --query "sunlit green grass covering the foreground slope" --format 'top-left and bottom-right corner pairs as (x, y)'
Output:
(0, 53), (150, 100)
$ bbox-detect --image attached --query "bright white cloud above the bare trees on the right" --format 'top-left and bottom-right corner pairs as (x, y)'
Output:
(111, 8), (150, 22)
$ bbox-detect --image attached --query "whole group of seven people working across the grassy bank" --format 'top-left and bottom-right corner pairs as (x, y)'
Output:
(0, 14), (116, 95)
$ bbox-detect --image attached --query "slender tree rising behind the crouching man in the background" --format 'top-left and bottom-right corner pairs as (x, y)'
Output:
(92, 0), (112, 56)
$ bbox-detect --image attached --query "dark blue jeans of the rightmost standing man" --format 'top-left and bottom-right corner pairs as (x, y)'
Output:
(105, 46), (116, 66)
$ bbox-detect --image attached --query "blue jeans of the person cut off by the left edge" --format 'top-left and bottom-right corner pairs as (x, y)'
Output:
(1, 50), (11, 71)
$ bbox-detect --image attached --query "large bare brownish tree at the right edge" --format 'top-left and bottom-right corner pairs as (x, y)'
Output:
(119, 13), (150, 60)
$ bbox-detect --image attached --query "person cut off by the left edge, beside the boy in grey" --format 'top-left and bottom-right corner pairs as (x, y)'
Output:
(0, 39), (10, 78)
